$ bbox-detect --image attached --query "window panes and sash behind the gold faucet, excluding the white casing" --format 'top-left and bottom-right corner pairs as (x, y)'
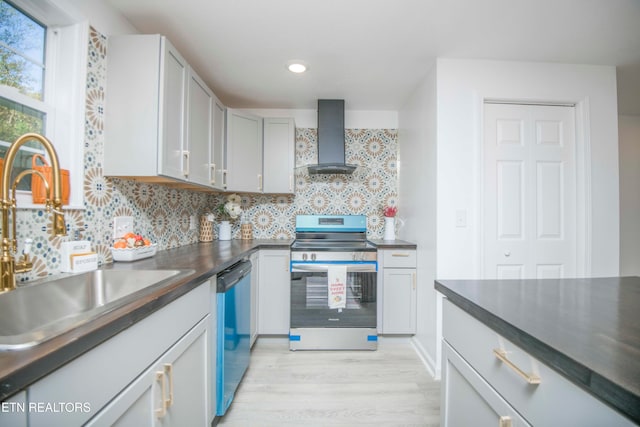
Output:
(0, 0), (47, 190)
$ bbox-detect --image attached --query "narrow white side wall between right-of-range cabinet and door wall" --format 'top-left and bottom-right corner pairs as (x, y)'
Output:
(398, 64), (440, 378)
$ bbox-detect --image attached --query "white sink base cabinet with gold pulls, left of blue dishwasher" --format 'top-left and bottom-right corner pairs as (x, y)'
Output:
(27, 281), (210, 427)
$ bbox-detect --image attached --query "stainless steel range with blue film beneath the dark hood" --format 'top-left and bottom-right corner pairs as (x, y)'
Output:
(289, 215), (378, 350)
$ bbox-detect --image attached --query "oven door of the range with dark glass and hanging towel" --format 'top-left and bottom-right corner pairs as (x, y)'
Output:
(291, 261), (377, 328)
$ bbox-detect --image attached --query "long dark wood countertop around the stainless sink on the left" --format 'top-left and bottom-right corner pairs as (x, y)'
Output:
(0, 240), (291, 401)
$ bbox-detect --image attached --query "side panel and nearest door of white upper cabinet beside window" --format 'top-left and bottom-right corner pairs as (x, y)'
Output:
(104, 35), (188, 181)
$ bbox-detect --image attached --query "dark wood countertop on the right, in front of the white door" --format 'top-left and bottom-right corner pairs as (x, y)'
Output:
(435, 277), (640, 424)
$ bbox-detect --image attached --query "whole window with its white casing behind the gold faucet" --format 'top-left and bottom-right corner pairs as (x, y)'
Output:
(0, 0), (89, 208)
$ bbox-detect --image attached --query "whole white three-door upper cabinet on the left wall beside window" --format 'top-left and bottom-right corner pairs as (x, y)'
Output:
(104, 34), (225, 189)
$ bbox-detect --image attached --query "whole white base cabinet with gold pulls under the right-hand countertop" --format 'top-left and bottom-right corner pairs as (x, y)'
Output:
(441, 299), (634, 427)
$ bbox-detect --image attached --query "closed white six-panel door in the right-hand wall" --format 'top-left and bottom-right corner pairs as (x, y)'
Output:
(483, 103), (577, 279)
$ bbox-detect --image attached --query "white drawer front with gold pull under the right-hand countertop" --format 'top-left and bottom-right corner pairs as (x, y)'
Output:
(443, 300), (633, 426)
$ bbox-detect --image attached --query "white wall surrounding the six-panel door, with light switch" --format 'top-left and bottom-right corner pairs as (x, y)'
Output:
(436, 59), (619, 279)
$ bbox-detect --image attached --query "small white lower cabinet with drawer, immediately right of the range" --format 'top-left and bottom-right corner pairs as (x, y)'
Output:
(378, 249), (418, 335)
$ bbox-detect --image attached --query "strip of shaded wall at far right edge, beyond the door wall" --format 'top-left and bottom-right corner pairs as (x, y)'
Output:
(618, 116), (640, 276)
